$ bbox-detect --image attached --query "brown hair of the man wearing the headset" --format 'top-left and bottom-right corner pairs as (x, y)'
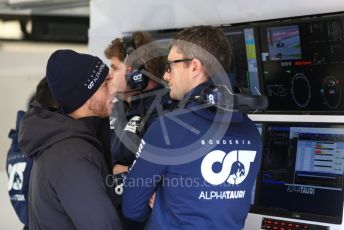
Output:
(104, 31), (165, 78)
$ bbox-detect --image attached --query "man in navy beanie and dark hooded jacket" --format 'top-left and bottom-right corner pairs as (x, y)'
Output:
(19, 50), (122, 229)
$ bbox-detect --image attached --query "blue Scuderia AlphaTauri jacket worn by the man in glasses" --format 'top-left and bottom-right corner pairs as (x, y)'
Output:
(122, 84), (261, 230)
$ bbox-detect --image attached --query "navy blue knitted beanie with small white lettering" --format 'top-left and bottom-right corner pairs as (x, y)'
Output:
(46, 50), (109, 114)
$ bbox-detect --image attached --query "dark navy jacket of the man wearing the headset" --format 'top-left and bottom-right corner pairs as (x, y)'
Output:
(110, 87), (175, 166)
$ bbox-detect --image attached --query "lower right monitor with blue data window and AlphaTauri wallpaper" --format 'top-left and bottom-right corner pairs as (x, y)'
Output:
(253, 123), (344, 224)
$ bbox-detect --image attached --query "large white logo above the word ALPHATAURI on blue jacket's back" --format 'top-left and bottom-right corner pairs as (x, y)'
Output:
(201, 150), (256, 185)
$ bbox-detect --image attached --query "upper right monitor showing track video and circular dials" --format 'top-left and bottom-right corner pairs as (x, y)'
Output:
(259, 15), (344, 114)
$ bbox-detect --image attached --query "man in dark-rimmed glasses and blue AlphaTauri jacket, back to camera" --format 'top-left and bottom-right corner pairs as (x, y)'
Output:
(122, 26), (261, 230)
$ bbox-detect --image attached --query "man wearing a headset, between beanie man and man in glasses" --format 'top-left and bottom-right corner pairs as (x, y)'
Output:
(104, 32), (173, 229)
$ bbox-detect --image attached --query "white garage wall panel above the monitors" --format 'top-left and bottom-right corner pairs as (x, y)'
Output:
(89, 0), (344, 60)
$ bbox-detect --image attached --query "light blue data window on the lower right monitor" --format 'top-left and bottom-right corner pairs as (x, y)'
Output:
(290, 128), (344, 190)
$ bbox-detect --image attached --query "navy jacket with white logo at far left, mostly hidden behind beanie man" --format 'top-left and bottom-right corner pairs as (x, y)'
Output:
(6, 111), (33, 226)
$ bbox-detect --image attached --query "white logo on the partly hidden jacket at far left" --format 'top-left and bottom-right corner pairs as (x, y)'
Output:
(7, 162), (26, 191)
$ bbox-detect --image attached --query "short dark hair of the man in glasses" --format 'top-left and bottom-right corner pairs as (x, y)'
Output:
(170, 26), (232, 77)
